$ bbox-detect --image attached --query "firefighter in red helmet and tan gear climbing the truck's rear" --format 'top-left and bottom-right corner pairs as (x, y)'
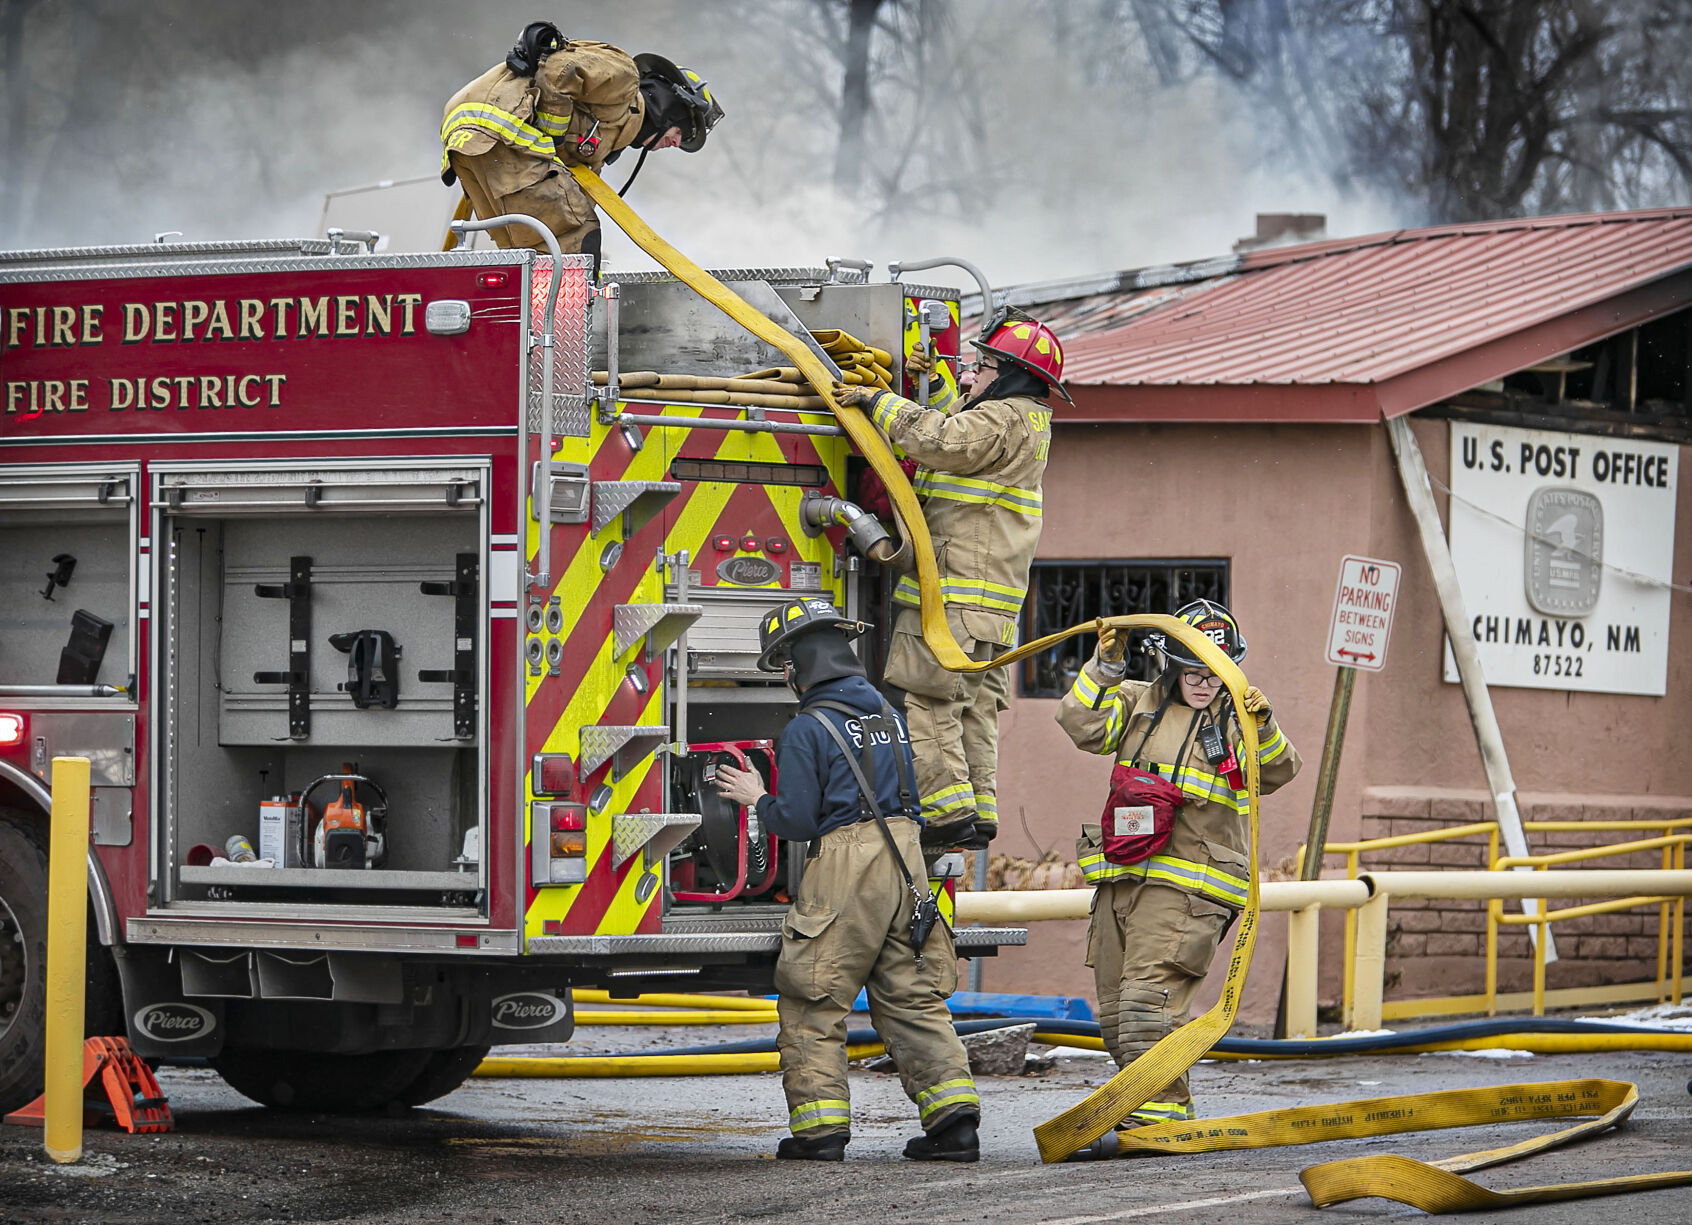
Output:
(834, 308), (1069, 848)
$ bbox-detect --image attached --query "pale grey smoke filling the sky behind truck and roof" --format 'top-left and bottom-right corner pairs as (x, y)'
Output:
(0, 0), (1408, 284)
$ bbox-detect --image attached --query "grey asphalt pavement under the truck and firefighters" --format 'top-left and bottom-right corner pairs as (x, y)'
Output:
(0, 1025), (1692, 1225)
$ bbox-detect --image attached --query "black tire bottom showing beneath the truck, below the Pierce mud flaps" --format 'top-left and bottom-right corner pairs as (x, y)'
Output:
(212, 1047), (435, 1115)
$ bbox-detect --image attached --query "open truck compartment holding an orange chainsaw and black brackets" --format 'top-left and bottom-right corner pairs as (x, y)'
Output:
(154, 469), (487, 913)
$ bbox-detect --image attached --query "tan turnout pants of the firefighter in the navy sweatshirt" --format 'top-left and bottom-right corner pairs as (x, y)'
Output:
(775, 817), (981, 1139)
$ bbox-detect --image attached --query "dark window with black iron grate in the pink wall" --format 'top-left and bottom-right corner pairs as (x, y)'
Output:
(1017, 558), (1228, 697)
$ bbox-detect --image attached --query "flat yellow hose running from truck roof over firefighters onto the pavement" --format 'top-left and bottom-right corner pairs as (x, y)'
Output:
(570, 166), (1692, 1211)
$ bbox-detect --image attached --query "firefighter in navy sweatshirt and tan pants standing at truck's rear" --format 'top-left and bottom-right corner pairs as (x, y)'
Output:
(716, 597), (981, 1161)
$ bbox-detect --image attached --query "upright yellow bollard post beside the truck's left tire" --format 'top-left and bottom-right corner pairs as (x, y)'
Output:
(41, 756), (88, 1164)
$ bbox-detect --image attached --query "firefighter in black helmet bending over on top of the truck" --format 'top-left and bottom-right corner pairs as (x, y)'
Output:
(440, 22), (722, 266)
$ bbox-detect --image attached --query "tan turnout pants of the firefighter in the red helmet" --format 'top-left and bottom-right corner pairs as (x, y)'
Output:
(885, 609), (1010, 826)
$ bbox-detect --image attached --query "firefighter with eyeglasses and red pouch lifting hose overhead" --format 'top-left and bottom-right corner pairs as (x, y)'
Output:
(1058, 599), (1303, 1157)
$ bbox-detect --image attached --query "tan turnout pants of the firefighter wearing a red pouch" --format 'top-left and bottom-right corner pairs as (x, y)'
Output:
(1086, 880), (1233, 1118)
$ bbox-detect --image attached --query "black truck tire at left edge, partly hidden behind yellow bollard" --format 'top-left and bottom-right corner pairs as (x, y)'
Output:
(0, 809), (125, 1113)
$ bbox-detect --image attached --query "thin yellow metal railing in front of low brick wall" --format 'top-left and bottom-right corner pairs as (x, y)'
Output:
(1296, 817), (1692, 1024)
